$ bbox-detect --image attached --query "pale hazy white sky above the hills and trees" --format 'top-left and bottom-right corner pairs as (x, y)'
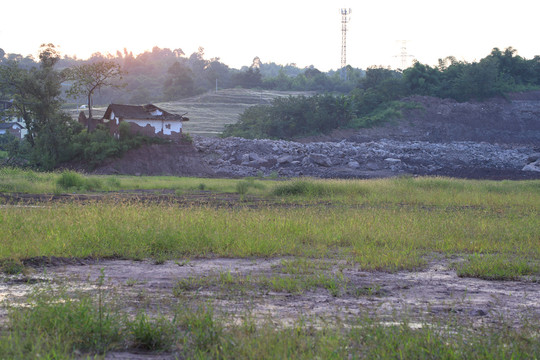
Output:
(0, 0), (540, 71)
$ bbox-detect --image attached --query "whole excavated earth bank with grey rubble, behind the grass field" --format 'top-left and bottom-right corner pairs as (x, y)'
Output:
(89, 91), (540, 179)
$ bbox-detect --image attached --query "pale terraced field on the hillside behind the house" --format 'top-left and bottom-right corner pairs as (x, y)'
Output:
(68, 89), (314, 136)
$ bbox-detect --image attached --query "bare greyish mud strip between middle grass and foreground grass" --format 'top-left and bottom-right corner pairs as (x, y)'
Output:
(0, 258), (540, 326)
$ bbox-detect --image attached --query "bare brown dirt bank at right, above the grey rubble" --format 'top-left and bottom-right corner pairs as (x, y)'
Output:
(308, 95), (540, 146)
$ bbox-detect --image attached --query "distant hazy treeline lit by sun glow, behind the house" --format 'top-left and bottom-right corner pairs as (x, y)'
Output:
(0, 46), (364, 105)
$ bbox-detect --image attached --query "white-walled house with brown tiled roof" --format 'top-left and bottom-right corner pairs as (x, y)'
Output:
(101, 104), (189, 141)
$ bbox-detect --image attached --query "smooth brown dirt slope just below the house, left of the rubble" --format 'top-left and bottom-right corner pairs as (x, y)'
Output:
(93, 144), (214, 177)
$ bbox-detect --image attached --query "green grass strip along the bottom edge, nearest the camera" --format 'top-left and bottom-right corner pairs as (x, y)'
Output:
(0, 296), (540, 359)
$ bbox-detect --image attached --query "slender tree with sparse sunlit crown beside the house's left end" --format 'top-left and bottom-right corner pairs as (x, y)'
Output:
(66, 60), (124, 118)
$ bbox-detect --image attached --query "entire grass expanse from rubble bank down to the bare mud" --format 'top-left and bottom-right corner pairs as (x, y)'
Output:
(0, 175), (540, 271)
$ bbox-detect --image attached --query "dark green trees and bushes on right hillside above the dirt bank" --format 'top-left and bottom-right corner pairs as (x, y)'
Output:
(223, 47), (540, 139)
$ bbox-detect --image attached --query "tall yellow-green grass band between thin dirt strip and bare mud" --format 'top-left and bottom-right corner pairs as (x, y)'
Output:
(0, 195), (540, 271)
